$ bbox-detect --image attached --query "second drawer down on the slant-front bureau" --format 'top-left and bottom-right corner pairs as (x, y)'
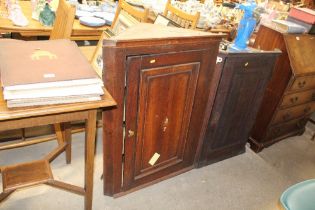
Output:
(281, 90), (315, 108)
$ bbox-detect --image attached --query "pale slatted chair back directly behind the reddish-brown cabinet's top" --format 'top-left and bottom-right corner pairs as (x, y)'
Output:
(163, 0), (200, 29)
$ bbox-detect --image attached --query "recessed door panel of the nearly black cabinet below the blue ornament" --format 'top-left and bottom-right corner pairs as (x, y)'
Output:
(204, 57), (273, 160)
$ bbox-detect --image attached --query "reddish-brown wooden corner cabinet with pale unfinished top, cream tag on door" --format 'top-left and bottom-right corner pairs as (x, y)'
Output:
(103, 24), (221, 196)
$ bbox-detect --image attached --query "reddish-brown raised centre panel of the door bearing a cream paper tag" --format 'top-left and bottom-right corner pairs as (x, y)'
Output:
(135, 64), (199, 179)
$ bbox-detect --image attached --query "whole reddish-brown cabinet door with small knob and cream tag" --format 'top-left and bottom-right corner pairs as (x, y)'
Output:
(123, 55), (200, 190)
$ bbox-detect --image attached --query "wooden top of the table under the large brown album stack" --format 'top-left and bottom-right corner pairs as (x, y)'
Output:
(0, 88), (116, 122)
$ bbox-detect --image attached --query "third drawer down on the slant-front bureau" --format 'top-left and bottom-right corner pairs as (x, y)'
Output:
(272, 102), (315, 124)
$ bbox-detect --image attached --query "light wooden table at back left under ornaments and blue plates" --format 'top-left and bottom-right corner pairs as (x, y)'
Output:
(0, 1), (109, 40)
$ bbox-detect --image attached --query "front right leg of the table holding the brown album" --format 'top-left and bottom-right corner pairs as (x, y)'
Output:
(84, 110), (96, 210)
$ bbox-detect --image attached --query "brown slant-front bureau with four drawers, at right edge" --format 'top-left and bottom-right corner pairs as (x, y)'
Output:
(249, 25), (315, 152)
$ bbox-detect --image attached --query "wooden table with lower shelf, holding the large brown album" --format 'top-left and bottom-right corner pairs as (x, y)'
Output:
(0, 90), (116, 210)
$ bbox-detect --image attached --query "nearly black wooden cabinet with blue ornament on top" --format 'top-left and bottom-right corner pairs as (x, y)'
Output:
(198, 49), (280, 167)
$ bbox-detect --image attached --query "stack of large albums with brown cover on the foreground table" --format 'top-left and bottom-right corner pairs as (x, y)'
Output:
(0, 39), (104, 108)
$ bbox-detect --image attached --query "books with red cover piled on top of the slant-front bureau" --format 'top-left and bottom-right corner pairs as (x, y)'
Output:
(272, 7), (315, 34)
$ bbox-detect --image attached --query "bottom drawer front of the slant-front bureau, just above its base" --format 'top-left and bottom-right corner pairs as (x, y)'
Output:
(266, 118), (307, 139)
